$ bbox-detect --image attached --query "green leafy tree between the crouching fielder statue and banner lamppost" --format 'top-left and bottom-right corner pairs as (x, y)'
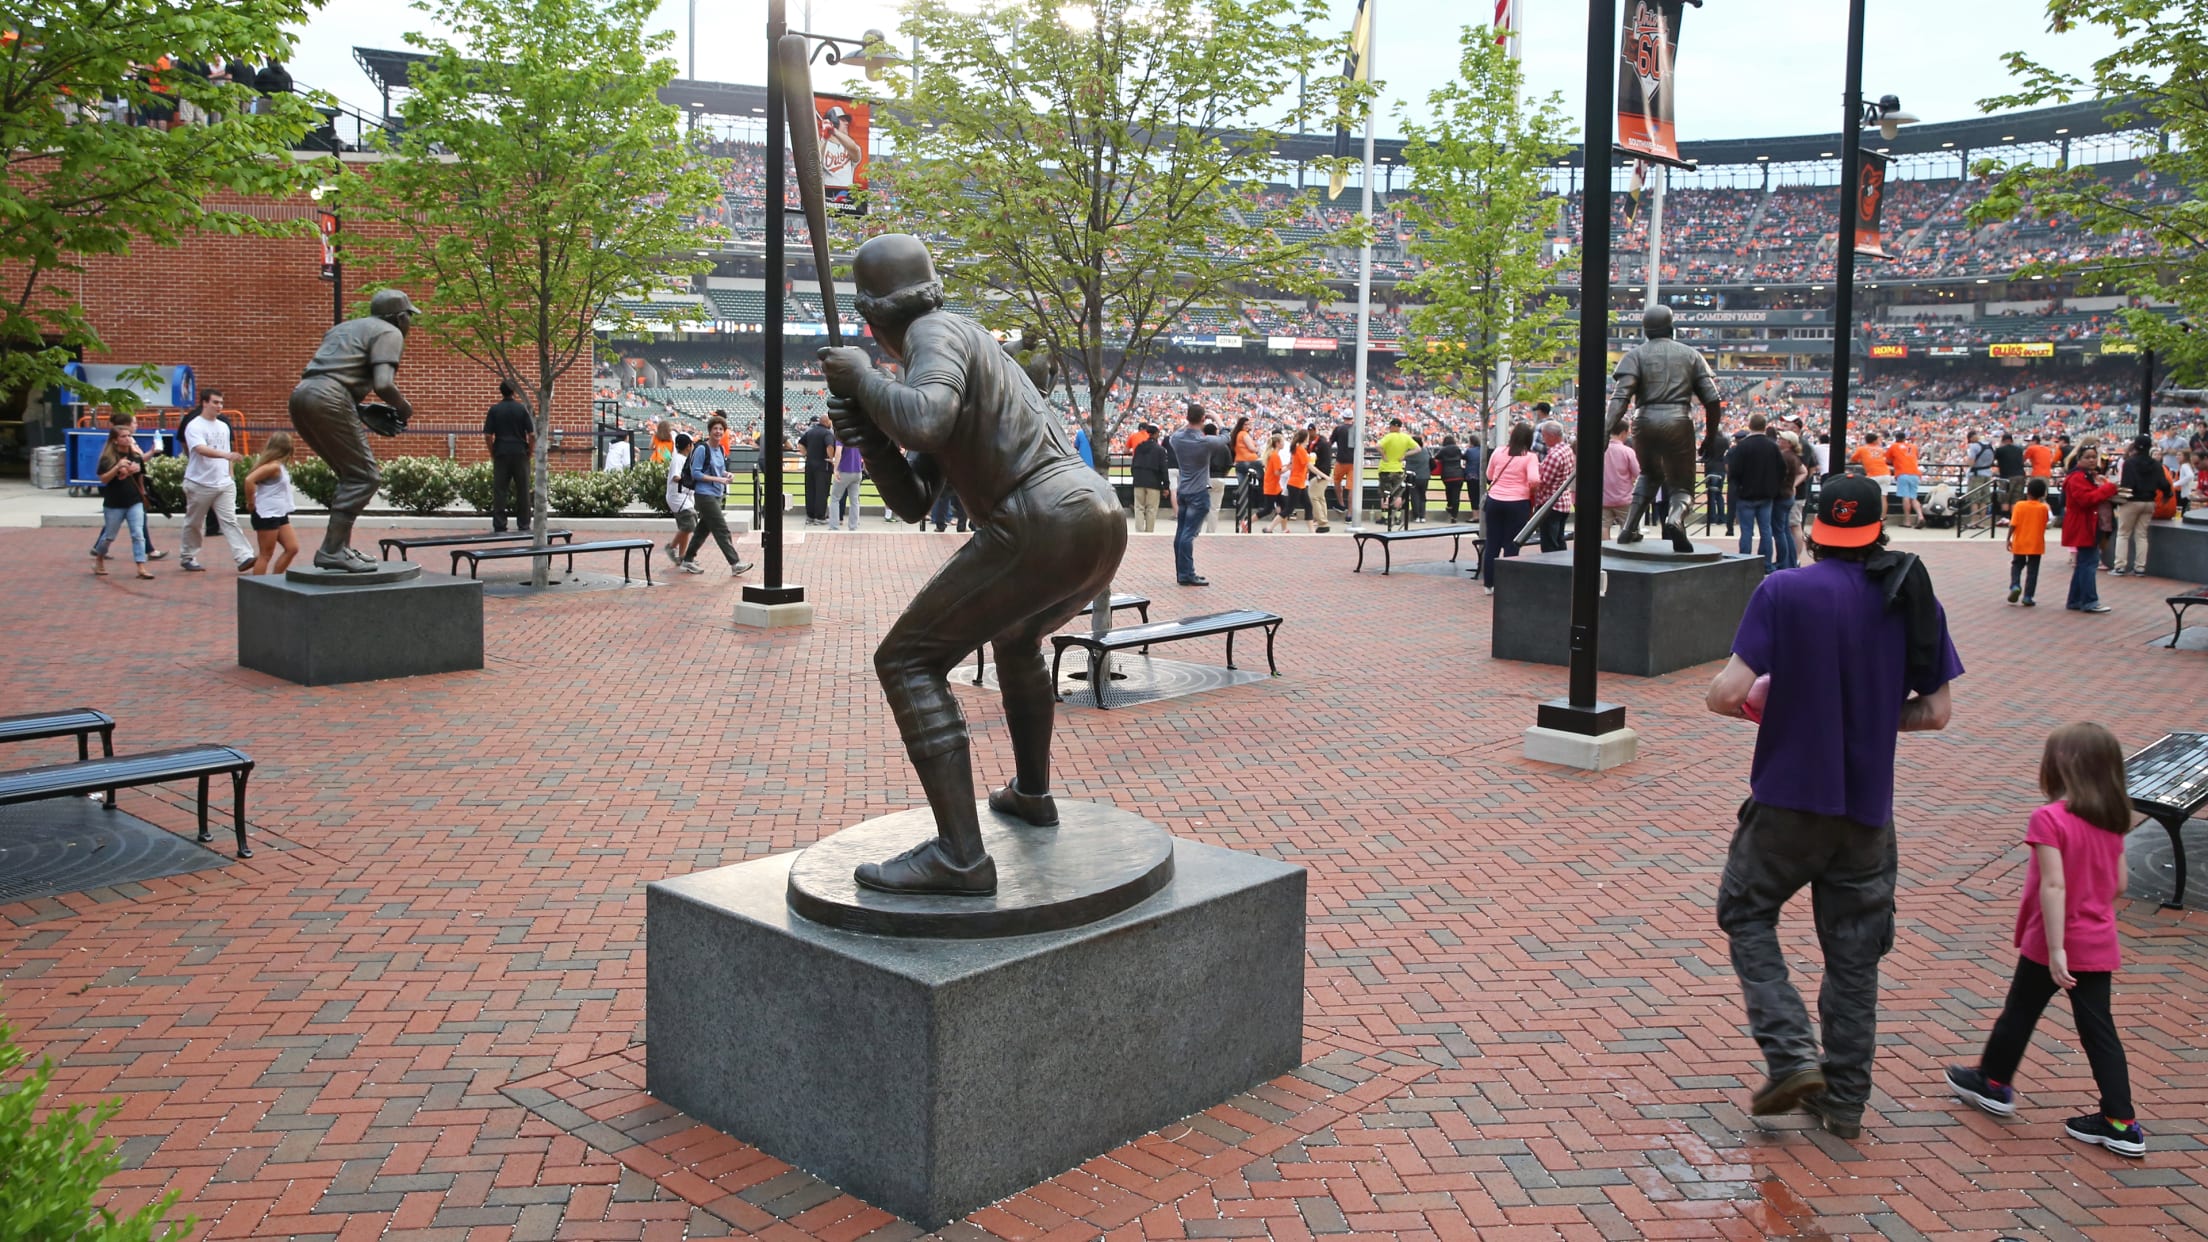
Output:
(342, 0), (720, 586)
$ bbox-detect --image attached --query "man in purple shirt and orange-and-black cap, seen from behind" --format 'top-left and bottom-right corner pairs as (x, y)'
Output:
(1709, 477), (1963, 1138)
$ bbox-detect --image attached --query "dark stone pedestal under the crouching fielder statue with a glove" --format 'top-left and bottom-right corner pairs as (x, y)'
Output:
(238, 572), (484, 685)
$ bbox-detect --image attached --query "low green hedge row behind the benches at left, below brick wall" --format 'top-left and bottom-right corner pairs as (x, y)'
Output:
(146, 457), (667, 517)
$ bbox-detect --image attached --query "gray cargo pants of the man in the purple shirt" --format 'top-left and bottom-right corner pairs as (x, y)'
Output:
(1718, 798), (1899, 1114)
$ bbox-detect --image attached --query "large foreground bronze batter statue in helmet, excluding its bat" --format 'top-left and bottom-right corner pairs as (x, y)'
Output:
(821, 232), (1126, 895)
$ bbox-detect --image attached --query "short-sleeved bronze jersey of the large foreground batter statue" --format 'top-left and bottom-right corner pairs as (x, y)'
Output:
(866, 312), (1089, 522)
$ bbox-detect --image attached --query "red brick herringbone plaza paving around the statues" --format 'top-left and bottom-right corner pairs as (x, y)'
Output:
(0, 530), (2208, 1242)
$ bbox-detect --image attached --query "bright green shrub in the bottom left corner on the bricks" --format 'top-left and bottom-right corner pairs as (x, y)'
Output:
(0, 1012), (199, 1242)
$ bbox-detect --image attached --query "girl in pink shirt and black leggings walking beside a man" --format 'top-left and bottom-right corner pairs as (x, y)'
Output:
(1947, 725), (2146, 1156)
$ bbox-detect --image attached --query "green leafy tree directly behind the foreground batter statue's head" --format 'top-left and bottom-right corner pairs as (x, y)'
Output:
(877, 0), (1362, 453)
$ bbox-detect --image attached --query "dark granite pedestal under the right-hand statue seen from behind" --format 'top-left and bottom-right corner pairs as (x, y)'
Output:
(1488, 541), (1764, 676)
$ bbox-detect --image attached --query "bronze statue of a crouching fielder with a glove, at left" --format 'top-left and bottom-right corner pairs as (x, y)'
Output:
(291, 290), (415, 575)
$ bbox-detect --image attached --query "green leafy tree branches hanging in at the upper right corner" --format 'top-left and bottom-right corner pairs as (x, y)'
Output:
(1970, 0), (2208, 385)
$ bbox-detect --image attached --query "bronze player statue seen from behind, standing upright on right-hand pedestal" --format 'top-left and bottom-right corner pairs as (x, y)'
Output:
(1610, 305), (1724, 552)
